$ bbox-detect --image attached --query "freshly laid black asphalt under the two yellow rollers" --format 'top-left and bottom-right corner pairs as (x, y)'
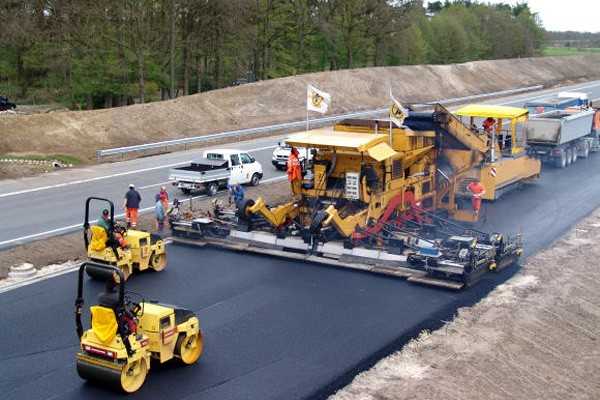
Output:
(0, 246), (509, 400)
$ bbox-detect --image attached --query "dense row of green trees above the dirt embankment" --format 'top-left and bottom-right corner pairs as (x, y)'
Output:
(0, 0), (544, 109)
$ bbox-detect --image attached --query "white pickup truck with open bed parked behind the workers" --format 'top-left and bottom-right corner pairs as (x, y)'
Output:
(169, 149), (263, 196)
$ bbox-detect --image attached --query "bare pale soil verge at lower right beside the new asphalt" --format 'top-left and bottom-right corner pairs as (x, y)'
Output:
(330, 210), (600, 400)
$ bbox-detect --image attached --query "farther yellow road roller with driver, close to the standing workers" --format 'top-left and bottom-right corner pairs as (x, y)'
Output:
(83, 197), (167, 280)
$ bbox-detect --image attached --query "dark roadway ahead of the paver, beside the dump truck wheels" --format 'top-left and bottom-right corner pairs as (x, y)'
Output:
(479, 153), (600, 255)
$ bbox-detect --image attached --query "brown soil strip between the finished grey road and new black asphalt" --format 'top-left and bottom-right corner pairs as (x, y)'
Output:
(0, 181), (289, 279)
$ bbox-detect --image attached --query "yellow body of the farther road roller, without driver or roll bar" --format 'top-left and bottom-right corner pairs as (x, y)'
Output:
(87, 226), (167, 279)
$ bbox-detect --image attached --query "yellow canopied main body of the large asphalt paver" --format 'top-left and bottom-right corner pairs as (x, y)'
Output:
(248, 121), (435, 237)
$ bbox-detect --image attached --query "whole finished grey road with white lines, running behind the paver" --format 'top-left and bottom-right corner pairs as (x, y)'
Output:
(0, 81), (600, 249)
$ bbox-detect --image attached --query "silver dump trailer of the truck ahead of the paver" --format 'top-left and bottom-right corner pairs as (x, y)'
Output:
(526, 110), (600, 168)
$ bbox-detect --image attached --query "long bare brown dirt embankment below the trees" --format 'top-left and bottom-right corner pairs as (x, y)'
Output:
(0, 55), (600, 159)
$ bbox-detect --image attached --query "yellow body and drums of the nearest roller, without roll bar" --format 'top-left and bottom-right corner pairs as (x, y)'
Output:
(77, 303), (203, 393)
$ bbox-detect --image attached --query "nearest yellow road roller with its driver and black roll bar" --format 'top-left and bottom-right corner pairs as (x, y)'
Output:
(75, 261), (203, 393)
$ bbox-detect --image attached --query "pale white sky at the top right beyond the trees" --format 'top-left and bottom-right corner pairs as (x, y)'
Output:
(426, 0), (600, 32)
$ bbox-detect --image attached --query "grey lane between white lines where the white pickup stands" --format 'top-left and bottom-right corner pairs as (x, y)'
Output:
(0, 147), (282, 246)
